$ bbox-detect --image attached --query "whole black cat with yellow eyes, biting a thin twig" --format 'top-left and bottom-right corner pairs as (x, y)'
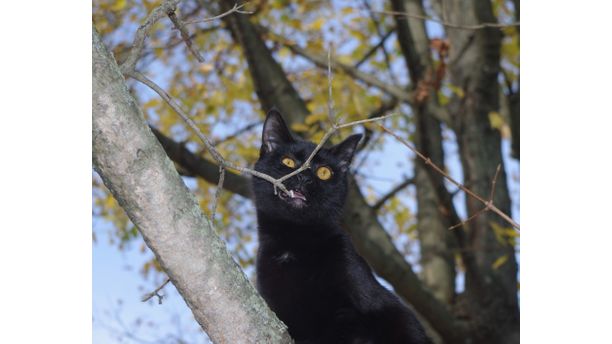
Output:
(253, 109), (429, 344)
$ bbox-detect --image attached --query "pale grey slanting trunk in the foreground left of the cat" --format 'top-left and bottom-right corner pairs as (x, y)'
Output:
(92, 28), (292, 344)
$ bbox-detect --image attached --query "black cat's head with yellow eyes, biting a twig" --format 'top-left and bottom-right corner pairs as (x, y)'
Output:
(253, 109), (362, 224)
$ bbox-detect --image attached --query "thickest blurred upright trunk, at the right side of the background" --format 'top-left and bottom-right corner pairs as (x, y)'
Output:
(443, 0), (519, 343)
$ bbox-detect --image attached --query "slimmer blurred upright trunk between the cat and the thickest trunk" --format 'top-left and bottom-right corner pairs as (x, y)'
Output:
(391, 0), (455, 304)
